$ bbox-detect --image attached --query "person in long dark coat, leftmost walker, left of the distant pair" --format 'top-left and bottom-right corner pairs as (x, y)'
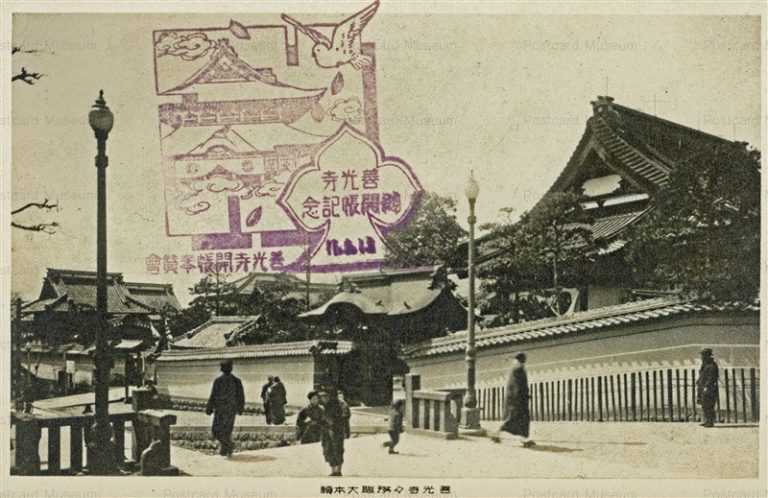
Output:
(205, 360), (245, 457)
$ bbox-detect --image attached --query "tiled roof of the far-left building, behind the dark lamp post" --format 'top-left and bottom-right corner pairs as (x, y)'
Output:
(23, 268), (181, 315)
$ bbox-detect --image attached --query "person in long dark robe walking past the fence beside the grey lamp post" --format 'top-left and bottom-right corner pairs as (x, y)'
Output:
(493, 353), (536, 448)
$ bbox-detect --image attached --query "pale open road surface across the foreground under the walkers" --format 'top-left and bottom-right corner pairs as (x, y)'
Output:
(172, 423), (758, 479)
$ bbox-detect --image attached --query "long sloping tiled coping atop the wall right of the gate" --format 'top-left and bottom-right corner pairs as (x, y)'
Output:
(404, 298), (759, 358)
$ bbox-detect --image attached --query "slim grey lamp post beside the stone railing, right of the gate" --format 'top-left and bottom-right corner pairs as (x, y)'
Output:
(461, 171), (482, 431)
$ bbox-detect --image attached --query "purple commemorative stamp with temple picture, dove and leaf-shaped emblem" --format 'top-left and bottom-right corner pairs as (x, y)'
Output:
(153, 2), (422, 272)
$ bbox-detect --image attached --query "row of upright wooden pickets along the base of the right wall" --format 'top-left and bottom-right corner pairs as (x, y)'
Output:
(478, 368), (760, 423)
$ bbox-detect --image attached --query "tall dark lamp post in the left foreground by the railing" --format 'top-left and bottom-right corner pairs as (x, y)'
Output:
(88, 90), (114, 474)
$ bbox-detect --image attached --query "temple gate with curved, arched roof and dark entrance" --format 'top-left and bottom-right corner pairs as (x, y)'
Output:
(299, 266), (467, 405)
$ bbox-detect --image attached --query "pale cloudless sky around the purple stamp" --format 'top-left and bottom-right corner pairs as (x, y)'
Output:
(11, 11), (761, 302)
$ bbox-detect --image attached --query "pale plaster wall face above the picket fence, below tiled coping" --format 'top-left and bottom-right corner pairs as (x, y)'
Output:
(407, 316), (760, 389)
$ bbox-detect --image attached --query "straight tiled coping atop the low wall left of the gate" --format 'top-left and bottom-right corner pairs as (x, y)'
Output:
(157, 340), (354, 362)
